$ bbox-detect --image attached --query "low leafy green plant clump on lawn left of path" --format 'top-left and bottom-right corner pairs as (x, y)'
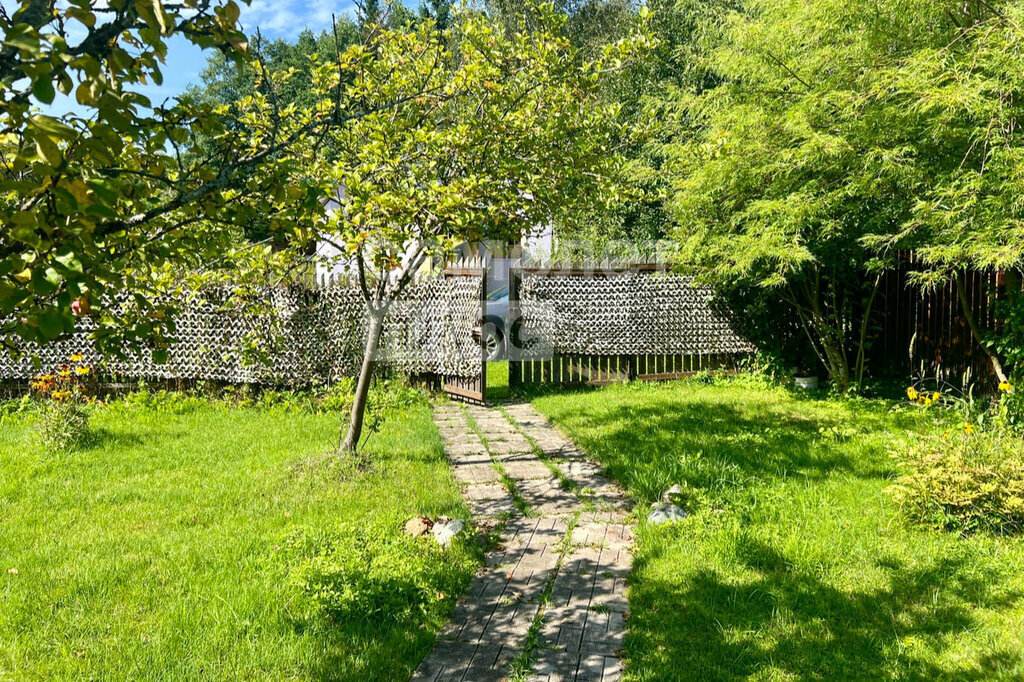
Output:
(285, 525), (475, 623)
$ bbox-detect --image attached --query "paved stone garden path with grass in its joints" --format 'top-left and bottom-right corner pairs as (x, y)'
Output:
(413, 404), (633, 682)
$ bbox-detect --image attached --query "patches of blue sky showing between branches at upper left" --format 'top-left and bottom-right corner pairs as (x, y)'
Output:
(19, 0), (419, 114)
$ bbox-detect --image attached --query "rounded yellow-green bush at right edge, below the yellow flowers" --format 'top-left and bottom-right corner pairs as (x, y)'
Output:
(888, 424), (1024, 535)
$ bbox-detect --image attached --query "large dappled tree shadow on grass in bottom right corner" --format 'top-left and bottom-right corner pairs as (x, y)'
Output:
(627, 534), (1022, 681)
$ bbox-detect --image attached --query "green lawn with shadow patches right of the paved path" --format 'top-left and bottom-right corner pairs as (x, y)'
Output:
(535, 379), (1024, 680)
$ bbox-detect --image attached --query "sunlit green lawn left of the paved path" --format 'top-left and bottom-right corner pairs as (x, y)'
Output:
(0, 395), (475, 680)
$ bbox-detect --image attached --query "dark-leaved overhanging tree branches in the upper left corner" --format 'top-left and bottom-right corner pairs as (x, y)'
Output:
(0, 0), (432, 358)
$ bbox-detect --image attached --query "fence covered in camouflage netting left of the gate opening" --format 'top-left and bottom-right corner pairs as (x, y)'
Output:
(0, 270), (484, 385)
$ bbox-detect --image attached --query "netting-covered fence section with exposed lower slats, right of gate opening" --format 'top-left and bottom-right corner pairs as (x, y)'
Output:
(509, 264), (754, 384)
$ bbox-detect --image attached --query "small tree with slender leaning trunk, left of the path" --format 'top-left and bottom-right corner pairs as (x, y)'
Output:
(264, 7), (645, 451)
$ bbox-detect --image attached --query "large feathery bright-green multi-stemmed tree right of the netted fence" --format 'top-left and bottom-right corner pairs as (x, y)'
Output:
(667, 0), (1020, 390)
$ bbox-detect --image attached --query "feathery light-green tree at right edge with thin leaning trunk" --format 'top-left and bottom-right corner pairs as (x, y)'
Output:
(870, 2), (1024, 382)
